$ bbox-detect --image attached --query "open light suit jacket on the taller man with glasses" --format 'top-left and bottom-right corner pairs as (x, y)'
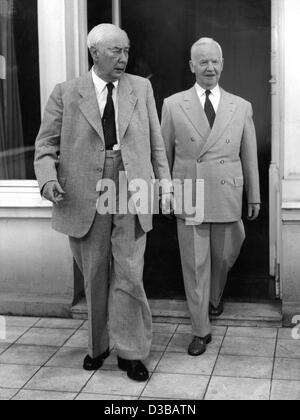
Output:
(35, 72), (170, 238)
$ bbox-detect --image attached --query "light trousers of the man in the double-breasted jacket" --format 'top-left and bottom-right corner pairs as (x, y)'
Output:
(177, 218), (245, 337)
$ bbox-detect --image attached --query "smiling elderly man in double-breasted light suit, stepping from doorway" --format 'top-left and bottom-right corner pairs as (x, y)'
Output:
(162, 38), (260, 356)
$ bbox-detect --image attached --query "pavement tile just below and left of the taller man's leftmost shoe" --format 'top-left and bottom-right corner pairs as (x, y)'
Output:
(25, 367), (92, 393)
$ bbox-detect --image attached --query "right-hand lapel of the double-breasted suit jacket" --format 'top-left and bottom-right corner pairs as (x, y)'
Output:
(201, 89), (236, 155)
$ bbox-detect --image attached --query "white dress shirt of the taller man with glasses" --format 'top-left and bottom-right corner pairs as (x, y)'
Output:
(92, 68), (120, 150)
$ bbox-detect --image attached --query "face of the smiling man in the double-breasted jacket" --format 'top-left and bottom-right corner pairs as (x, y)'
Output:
(190, 44), (224, 90)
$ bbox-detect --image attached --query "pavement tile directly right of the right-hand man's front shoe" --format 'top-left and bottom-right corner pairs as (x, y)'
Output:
(221, 336), (276, 357)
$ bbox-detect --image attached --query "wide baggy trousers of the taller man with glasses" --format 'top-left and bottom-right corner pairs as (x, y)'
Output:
(70, 151), (152, 360)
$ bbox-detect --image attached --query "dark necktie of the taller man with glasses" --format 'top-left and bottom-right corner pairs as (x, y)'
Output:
(102, 83), (118, 150)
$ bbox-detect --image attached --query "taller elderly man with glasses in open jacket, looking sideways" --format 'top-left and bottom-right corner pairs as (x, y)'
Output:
(35, 24), (171, 381)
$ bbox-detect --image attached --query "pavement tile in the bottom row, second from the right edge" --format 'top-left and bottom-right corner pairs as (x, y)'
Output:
(205, 376), (271, 401)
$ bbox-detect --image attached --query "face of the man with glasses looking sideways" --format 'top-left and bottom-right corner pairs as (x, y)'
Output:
(91, 33), (130, 83)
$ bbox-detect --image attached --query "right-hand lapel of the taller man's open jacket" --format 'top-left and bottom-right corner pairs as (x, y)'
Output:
(118, 75), (137, 141)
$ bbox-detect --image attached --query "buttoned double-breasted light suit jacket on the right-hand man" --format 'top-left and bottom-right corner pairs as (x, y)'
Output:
(162, 87), (260, 223)
